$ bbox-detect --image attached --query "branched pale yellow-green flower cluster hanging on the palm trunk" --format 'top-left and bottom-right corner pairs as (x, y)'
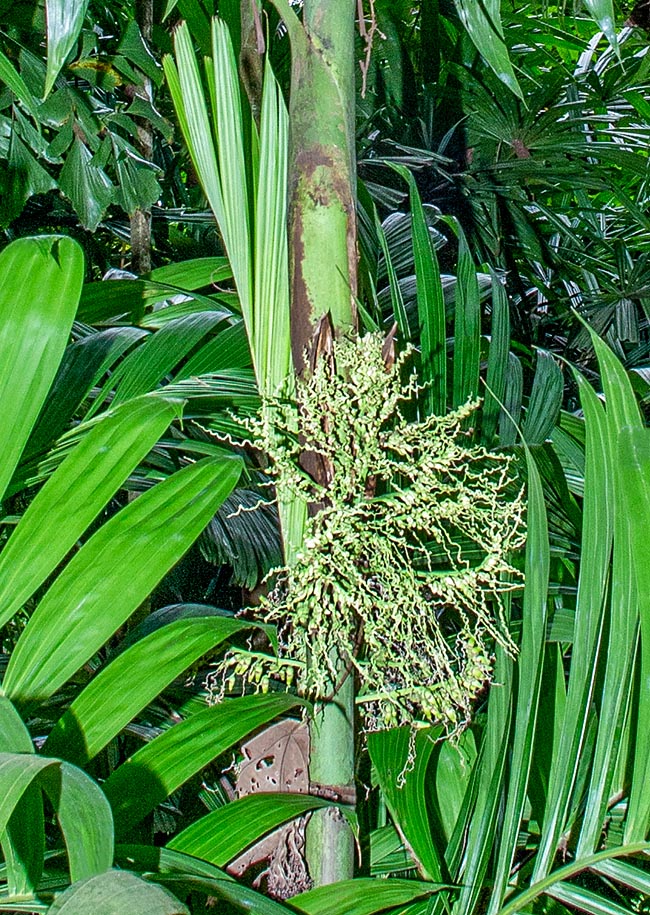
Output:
(216, 335), (524, 733)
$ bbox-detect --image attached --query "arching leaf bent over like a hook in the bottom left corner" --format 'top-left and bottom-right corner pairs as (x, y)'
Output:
(0, 753), (113, 881)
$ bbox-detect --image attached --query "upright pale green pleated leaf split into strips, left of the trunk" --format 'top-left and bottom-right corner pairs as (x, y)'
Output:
(163, 18), (305, 556)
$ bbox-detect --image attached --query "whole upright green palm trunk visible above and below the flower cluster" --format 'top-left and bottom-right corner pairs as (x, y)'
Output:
(270, 0), (357, 885)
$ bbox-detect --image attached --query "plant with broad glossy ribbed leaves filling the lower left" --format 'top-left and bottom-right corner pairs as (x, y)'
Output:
(0, 236), (306, 915)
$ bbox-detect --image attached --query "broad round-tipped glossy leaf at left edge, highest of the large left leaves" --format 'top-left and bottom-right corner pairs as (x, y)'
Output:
(0, 235), (84, 499)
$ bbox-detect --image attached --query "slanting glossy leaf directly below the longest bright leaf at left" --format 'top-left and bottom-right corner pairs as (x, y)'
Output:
(45, 616), (249, 766)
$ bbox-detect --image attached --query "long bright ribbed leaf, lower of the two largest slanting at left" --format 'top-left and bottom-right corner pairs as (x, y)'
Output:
(4, 459), (241, 704)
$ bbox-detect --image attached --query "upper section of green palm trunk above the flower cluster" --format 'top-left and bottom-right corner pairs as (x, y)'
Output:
(282, 0), (357, 373)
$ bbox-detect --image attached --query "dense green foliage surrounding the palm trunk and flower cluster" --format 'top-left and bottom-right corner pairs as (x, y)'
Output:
(0, 0), (650, 915)
